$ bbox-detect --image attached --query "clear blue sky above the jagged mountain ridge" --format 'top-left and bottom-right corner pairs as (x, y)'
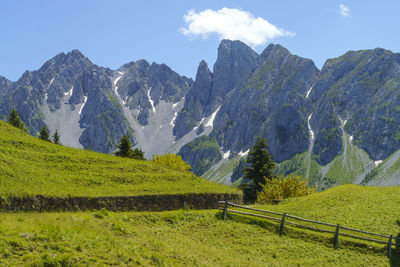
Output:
(0, 0), (400, 80)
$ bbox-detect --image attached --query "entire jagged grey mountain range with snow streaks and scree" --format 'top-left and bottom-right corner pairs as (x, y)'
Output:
(0, 40), (400, 188)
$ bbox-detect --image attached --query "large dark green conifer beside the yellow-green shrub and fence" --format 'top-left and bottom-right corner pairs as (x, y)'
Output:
(243, 137), (275, 193)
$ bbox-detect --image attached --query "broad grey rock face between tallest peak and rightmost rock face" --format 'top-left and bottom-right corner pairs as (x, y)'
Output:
(211, 45), (319, 162)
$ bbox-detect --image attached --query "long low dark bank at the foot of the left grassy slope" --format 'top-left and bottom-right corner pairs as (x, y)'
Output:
(0, 193), (243, 212)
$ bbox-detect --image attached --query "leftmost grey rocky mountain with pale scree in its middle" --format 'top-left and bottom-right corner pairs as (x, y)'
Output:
(0, 50), (128, 152)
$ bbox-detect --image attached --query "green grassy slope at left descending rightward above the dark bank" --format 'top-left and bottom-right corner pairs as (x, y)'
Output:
(0, 121), (238, 196)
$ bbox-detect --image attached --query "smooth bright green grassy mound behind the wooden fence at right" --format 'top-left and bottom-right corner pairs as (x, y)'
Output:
(257, 184), (400, 236)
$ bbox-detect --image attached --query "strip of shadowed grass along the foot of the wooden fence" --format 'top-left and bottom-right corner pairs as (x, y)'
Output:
(216, 212), (388, 258)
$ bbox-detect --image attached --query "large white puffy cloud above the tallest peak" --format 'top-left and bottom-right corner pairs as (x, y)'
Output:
(180, 7), (294, 47)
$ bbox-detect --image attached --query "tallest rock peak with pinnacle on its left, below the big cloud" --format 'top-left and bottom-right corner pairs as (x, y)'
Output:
(174, 40), (258, 139)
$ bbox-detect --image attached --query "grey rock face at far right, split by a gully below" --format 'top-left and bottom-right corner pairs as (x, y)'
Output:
(310, 48), (400, 165)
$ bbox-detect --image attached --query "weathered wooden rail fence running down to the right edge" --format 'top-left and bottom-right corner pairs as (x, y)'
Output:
(219, 201), (400, 257)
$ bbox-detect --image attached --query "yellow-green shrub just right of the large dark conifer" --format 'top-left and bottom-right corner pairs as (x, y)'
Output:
(257, 175), (315, 202)
